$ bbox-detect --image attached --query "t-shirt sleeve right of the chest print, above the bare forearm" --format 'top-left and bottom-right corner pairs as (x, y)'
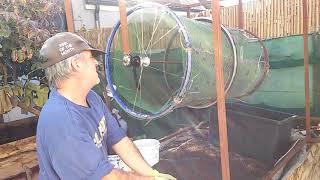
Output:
(105, 109), (126, 147)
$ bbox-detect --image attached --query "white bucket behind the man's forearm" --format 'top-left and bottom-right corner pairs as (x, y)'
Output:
(133, 139), (160, 166)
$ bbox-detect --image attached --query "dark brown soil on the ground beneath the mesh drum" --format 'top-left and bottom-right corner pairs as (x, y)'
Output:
(156, 122), (268, 180)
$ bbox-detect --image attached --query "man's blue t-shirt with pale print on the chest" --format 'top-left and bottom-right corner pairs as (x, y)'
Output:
(36, 90), (126, 180)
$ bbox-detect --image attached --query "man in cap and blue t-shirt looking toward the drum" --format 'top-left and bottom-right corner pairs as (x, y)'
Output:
(37, 32), (175, 180)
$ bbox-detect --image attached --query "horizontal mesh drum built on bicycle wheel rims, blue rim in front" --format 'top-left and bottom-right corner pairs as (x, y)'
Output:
(105, 3), (267, 120)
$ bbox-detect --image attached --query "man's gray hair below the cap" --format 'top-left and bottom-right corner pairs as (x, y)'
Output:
(45, 54), (80, 88)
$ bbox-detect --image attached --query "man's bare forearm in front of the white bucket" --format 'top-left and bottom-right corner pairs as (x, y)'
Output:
(112, 137), (153, 176)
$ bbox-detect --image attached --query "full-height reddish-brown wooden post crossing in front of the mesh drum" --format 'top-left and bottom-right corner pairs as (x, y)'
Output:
(211, 0), (230, 180)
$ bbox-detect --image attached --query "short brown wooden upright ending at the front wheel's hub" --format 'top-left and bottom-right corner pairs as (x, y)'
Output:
(119, 0), (130, 55)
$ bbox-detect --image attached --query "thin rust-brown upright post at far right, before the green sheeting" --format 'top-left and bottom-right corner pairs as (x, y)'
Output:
(302, 0), (311, 142)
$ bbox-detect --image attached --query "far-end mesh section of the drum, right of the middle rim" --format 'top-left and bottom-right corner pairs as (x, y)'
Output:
(228, 29), (269, 97)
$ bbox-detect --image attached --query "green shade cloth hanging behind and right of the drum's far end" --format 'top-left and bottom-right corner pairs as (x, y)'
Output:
(243, 34), (320, 114)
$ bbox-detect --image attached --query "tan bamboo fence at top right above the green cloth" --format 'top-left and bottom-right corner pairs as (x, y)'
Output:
(220, 0), (320, 39)
